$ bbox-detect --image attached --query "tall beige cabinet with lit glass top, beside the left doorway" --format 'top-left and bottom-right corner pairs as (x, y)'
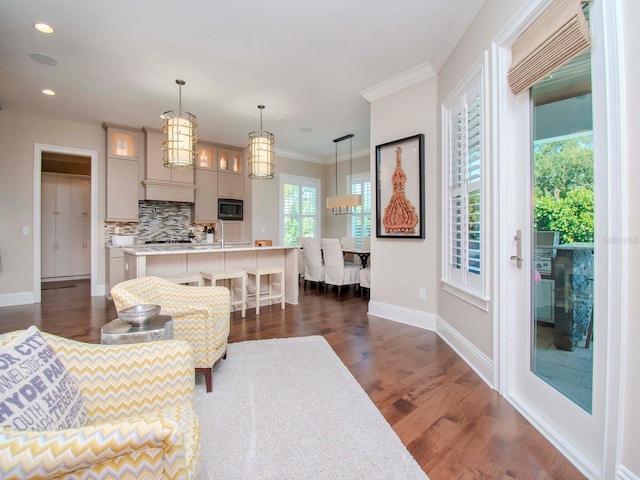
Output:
(102, 123), (142, 222)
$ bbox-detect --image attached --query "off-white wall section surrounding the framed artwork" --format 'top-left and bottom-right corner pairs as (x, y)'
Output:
(370, 78), (440, 315)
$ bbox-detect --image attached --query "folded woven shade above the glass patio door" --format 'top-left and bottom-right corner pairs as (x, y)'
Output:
(507, 0), (591, 95)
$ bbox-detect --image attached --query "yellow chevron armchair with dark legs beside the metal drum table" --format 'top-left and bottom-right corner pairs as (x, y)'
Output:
(111, 276), (231, 392)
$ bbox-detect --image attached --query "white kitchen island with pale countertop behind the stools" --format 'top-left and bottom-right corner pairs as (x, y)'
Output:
(123, 244), (298, 305)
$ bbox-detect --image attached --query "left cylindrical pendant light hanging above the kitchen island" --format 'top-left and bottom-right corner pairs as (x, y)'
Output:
(161, 79), (198, 168)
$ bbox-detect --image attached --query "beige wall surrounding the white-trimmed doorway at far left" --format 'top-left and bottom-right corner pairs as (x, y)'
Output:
(0, 109), (105, 294)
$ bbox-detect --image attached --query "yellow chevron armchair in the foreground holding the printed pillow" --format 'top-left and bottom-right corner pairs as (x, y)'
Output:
(0, 332), (200, 480)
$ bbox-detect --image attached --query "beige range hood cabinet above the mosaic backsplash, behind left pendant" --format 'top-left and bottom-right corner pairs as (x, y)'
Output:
(143, 128), (195, 203)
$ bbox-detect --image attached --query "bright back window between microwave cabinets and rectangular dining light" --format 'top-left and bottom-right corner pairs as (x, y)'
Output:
(280, 174), (320, 246)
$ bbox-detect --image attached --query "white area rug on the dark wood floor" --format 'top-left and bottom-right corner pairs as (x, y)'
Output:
(196, 336), (427, 480)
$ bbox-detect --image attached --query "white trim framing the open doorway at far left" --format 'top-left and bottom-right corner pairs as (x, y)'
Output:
(33, 143), (99, 303)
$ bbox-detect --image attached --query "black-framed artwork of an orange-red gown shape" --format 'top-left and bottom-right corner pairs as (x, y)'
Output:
(376, 133), (425, 238)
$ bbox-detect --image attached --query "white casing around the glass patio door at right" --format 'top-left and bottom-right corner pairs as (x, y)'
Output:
(492, 0), (628, 479)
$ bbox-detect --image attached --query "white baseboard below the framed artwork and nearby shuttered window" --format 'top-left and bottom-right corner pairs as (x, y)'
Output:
(368, 301), (493, 389)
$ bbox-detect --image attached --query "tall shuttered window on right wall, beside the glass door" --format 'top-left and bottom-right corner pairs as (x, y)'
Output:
(442, 54), (488, 308)
